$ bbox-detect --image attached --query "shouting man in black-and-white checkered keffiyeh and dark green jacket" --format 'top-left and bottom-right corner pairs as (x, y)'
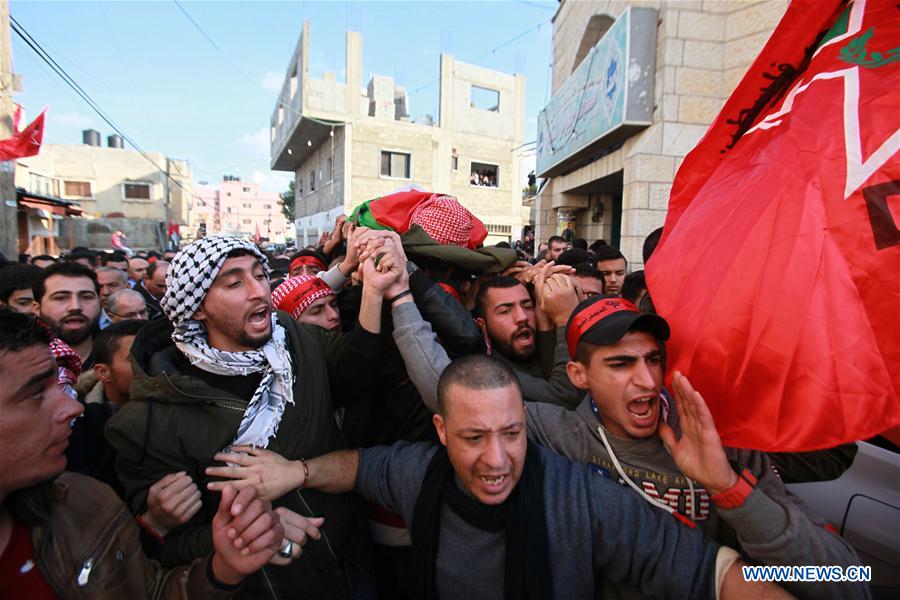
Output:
(106, 236), (379, 598)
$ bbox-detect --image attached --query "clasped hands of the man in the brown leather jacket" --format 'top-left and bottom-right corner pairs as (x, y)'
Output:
(212, 485), (284, 585)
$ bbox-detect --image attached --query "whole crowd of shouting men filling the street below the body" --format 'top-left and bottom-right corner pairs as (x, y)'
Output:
(0, 204), (869, 599)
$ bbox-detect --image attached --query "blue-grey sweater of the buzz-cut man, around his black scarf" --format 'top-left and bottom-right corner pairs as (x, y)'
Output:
(356, 442), (719, 600)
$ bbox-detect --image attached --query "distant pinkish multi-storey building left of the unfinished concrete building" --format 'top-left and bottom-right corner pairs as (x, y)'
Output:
(190, 175), (294, 243)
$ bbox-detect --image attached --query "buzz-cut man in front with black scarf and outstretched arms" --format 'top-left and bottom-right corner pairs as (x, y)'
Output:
(208, 354), (789, 600)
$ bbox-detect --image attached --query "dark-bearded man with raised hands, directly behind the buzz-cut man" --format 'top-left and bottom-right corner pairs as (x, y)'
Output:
(475, 276), (581, 408)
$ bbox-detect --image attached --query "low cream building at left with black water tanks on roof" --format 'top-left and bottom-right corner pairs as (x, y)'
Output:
(15, 130), (195, 248)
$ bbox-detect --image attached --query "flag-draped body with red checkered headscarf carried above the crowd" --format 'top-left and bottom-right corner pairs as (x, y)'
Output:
(349, 190), (516, 273)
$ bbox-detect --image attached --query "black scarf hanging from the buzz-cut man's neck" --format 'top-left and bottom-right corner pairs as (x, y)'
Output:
(410, 441), (553, 600)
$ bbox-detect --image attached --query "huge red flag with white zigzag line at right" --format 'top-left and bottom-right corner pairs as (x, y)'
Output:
(647, 0), (900, 451)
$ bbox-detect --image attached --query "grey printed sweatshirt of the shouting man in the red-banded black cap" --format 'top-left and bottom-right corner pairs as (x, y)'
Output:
(393, 303), (869, 598)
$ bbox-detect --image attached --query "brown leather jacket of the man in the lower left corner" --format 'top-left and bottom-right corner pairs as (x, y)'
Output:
(10, 473), (232, 600)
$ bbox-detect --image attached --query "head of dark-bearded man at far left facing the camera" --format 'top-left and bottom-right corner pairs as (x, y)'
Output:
(32, 262), (100, 371)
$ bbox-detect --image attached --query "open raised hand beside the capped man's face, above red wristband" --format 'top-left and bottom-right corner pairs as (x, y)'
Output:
(659, 371), (738, 495)
